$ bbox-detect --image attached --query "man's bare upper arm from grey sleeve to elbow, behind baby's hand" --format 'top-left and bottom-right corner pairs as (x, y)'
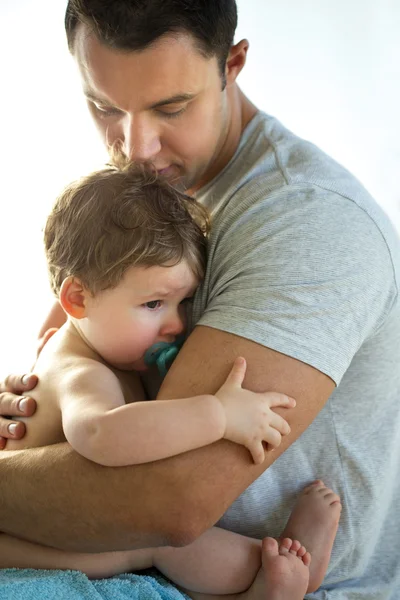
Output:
(158, 326), (335, 536)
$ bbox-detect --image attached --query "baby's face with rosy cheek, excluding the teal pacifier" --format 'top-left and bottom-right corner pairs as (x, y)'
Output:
(80, 261), (199, 371)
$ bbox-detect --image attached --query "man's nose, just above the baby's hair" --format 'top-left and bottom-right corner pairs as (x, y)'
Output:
(122, 115), (161, 163)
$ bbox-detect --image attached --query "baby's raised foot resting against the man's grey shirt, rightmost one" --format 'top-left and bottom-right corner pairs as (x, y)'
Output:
(282, 480), (342, 592)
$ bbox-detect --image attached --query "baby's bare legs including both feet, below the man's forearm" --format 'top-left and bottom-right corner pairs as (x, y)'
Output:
(0, 481), (341, 600)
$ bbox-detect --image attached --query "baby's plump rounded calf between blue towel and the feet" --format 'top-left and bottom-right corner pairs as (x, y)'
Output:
(151, 527), (261, 595)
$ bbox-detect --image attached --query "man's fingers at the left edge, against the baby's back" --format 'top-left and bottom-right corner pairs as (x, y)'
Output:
(0, 374), (38, 450)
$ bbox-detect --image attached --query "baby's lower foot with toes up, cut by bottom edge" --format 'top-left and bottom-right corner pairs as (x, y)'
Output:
(247, 537), (311, 600)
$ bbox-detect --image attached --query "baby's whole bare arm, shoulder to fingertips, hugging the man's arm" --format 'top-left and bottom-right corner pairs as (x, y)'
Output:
(60, 359), (295, 466)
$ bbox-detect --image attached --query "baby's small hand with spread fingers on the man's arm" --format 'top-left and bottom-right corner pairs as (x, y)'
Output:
(215, 357), (296, 464)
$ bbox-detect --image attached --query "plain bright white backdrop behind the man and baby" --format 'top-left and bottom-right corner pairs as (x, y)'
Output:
(0, 0), (400, 377)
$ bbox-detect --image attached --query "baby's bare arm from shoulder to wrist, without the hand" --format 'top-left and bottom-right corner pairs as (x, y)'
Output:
(59, 360), (225, 466)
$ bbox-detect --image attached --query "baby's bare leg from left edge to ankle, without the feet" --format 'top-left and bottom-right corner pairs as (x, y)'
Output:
(0, 528), (261, 594)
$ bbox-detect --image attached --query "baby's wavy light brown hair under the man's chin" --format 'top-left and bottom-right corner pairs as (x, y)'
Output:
(44, 164), (210, 296)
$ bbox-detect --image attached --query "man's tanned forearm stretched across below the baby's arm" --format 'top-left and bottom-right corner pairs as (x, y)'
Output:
(0, 441), (261, 552)
